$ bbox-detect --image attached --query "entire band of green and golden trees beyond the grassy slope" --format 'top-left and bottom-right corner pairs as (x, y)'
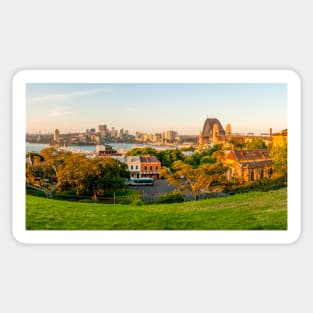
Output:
(26, 143), (287, 200)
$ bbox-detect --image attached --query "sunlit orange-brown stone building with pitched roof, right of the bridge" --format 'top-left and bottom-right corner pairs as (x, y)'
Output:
(224, 149), (273, 182)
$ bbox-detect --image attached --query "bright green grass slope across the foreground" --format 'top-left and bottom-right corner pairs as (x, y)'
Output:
(26, 188), (287, 230)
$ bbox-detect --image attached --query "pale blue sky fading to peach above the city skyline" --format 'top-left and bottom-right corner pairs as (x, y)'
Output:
(26, 83), (288, 135)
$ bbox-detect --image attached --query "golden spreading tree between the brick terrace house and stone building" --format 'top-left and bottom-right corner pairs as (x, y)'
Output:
(161, 161), (227, 200)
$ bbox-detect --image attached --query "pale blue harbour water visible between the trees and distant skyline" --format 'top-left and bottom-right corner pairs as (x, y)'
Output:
(26, 142), (176, 153)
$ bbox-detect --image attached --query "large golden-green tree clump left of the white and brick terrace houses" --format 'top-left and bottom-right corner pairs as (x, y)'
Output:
(26, 147), (130, 198)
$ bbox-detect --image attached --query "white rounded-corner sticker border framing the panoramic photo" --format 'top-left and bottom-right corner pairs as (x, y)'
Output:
(12, 70), (301, 244)
